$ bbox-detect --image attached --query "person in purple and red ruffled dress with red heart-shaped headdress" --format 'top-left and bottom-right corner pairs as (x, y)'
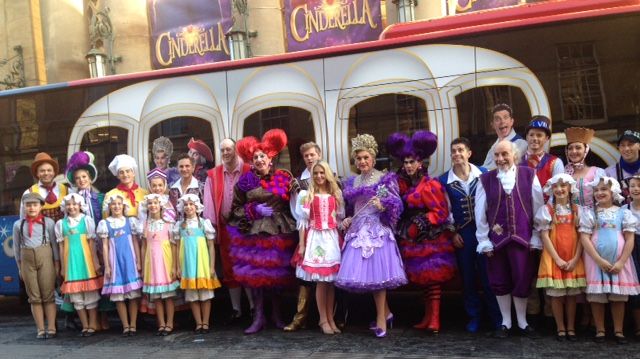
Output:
(227, 129), (298, 334)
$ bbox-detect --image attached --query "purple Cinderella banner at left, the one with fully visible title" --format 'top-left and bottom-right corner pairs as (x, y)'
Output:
(147, 0), (233, 69)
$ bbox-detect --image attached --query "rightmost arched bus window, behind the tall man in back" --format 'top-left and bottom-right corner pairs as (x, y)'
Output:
(456, 86), (531, 165)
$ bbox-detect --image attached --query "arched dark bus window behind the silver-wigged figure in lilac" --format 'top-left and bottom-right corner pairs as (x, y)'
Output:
(349, 94), (429, 172)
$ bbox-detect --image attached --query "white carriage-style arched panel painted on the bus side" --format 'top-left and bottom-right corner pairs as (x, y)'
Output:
(68, 44), (616, 182)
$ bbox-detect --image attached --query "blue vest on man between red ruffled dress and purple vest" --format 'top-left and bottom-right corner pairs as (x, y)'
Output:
(438, 167), (487, 231)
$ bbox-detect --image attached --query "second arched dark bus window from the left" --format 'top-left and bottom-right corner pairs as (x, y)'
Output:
(148, 116), (216, 169)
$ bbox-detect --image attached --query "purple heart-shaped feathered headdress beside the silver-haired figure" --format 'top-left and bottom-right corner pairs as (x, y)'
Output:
(387, 130), (438, 160)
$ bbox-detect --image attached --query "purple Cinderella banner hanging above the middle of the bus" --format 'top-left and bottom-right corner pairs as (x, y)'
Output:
(284, 0), (382, 52)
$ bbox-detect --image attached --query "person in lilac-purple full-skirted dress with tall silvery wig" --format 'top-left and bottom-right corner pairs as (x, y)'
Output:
(335, 134), (407, 338)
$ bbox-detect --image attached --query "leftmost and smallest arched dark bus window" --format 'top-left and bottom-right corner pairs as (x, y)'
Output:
(80, 126), (129, 193)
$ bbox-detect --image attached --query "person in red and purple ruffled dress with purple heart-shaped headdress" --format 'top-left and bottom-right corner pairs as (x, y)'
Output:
(387, 130), (456, 333)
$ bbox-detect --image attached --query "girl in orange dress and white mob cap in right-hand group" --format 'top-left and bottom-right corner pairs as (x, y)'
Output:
(534, 173), (587, 341)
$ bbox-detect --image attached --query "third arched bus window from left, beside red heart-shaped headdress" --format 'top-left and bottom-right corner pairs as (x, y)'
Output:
(243, 106), (316, 176)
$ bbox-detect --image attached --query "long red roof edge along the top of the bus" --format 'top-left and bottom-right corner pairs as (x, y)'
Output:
(0, 0), (640, 97)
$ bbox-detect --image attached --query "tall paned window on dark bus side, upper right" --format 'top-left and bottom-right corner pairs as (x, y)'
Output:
(556, 42), (607, 125)
